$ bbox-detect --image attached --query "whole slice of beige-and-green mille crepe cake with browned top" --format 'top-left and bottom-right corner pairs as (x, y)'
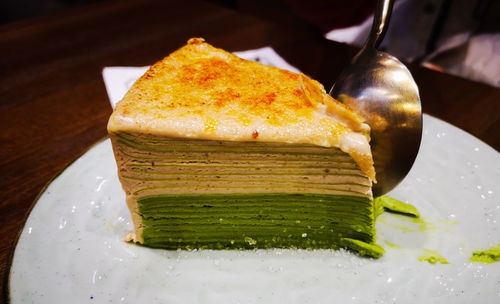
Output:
(108, 38), (377, 256)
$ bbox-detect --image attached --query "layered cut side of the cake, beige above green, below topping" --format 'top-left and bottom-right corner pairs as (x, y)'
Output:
(111, 132), (375, 253)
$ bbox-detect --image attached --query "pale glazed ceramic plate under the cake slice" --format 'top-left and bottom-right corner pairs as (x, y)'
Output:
(9, 116), (500, 304)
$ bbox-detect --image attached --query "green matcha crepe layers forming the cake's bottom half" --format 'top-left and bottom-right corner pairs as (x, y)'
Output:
(138, 193), (374, 249)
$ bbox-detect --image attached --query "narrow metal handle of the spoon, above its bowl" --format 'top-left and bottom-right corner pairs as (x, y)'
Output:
(363, 0), (394, 49)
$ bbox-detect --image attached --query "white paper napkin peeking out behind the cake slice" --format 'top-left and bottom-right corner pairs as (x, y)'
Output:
(102, 46), (300, 109)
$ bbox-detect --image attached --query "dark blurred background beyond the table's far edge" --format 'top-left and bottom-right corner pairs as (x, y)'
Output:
(0, 0), (500, 87)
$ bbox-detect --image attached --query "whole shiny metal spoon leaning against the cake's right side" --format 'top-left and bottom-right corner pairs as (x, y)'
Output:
(330, 0), (422, 196)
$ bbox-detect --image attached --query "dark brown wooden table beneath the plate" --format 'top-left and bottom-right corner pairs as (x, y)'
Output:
(0, 0), (500, 296)
